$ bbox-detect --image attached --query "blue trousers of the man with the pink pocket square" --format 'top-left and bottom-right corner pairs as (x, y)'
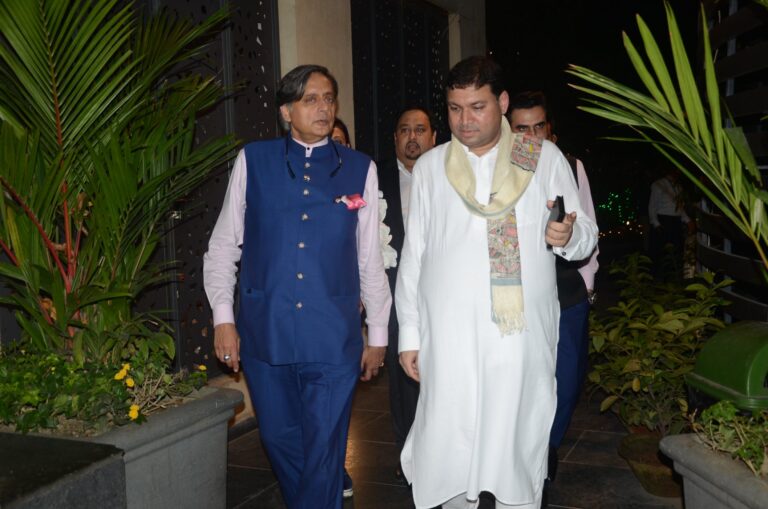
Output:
(242, 358), (360, 509)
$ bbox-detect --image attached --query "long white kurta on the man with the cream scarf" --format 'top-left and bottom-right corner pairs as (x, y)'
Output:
(395, 141), (597, 508)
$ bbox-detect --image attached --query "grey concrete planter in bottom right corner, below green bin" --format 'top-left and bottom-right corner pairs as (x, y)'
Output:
(660, 434), (768, 509)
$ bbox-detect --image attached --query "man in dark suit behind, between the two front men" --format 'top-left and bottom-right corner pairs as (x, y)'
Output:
(378, 107), (436, 482)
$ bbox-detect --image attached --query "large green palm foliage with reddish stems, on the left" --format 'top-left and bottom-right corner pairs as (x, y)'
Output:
(0, 0), (235, 361)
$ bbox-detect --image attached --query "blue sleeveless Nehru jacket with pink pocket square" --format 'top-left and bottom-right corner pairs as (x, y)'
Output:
(237, 138), (376, 365)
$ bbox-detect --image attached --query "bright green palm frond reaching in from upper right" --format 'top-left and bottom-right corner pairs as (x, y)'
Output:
(567, 2), (768, 269)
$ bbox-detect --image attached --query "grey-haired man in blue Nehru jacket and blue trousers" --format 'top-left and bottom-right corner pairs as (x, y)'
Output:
(204, 65), (391, 509)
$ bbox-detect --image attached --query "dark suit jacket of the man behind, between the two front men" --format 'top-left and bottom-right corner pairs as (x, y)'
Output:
(378, 159), (405, 337)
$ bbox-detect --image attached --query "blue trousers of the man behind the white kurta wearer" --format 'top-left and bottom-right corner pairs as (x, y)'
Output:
(549, 300), (589, 448)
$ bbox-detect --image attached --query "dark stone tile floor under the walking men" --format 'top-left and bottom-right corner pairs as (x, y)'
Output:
(227, 373), (682, 509)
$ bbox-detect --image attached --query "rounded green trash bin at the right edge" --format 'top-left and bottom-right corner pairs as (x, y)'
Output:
(685, 322), (768, 410)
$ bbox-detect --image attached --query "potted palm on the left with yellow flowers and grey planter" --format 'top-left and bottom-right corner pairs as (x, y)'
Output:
(0, 0), (241, 507)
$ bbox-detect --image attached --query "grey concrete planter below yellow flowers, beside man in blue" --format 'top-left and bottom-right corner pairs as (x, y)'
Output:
(91, 387), (243, 509)
